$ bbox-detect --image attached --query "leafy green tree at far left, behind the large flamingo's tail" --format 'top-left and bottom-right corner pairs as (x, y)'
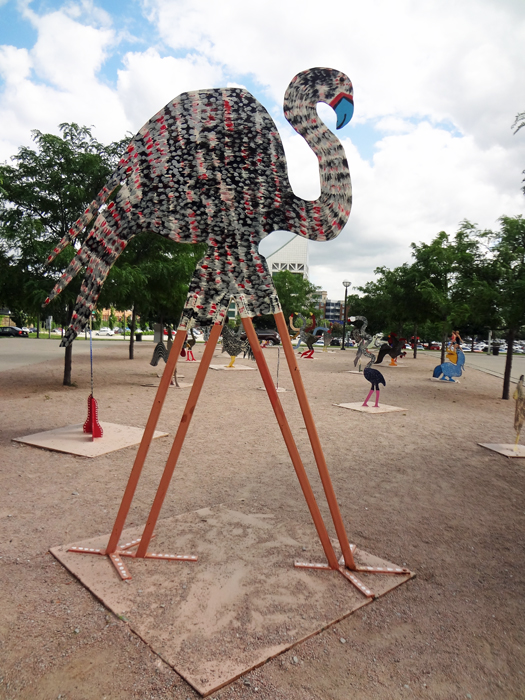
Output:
(0, 123), (127, 385)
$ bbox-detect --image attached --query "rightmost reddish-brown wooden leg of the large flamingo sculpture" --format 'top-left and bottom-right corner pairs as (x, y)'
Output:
(274, 312), (356, 570)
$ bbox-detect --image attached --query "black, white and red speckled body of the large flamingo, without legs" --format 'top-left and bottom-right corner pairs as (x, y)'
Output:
(46, 68), (353, 346)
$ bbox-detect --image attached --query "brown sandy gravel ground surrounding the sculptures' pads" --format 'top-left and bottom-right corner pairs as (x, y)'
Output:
(0, 344), (525, 700)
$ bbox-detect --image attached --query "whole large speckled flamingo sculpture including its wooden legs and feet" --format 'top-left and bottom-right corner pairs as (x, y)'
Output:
(49, 68), (407, 597)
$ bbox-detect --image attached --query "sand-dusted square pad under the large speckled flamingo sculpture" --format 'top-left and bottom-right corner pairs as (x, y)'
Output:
(51, 502), (413, 695)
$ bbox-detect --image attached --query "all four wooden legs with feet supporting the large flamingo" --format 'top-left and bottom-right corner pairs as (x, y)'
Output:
(68, 312), (410, 598)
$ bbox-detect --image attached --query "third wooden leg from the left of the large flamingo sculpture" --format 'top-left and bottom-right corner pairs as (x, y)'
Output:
(242, 313), (339, 570)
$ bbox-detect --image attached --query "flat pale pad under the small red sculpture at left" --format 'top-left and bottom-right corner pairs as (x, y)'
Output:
(13, 421), (168, 457)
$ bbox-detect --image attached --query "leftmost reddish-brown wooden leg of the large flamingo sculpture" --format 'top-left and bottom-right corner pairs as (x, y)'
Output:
(106, 330), (186, 554)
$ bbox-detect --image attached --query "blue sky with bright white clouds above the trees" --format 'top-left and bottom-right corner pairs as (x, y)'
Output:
(0, 0), (525, 299)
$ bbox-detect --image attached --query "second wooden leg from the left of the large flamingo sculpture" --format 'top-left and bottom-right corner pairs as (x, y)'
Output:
(135, 324), (222, 558)
